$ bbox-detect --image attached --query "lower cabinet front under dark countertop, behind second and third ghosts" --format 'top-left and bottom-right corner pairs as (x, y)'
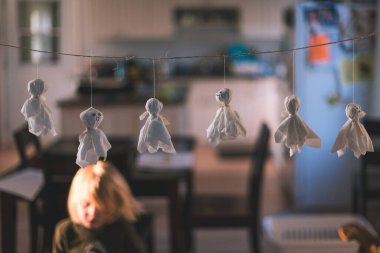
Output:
(61, 105), (189, 137)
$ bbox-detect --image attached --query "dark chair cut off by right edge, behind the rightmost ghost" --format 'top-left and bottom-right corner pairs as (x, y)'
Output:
(353, 117), (380, 217)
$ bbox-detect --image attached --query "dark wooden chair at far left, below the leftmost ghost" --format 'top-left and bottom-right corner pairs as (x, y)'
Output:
(13, 124), (53, 253)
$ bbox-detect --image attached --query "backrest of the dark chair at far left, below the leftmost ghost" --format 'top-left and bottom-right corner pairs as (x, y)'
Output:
(13, 124), (42, 166)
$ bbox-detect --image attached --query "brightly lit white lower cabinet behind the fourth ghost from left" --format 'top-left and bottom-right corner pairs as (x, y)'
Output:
(188, 78), (284, 148)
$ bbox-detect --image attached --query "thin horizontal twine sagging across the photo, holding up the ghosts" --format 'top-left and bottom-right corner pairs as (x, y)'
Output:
(0, 32), (380, 61)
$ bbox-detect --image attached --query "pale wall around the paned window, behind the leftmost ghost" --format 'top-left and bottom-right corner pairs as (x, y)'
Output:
(1, 1), (83, 146)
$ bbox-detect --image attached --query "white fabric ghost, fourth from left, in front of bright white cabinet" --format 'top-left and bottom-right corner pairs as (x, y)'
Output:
(206, 88), (247, 146)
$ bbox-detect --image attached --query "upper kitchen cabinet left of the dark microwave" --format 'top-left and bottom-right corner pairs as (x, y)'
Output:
(91, 0), (173, 41)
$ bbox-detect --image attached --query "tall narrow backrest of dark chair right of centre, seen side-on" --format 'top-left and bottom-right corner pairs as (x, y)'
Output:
(248, 123), (270, 224)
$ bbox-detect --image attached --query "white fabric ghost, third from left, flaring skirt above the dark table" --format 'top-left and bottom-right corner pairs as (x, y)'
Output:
(137, 98), (176, 153)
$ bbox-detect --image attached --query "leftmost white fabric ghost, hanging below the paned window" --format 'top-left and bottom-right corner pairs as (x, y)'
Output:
(21, 79), (57, 136)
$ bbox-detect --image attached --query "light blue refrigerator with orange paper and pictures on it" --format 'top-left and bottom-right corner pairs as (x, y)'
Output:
(294, 1), (376, 211)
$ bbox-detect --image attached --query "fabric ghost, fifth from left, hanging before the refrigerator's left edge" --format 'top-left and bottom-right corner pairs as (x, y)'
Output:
(274, 95), (321, 156)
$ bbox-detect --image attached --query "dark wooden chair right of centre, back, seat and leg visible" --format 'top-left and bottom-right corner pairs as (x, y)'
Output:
(189, 124), (270, 253)
